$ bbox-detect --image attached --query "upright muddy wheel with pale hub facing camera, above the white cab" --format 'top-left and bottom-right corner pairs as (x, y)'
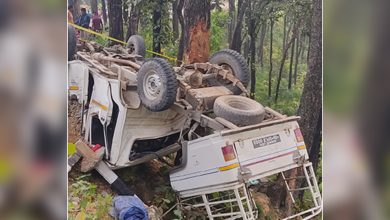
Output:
(137, 58), (178, 112)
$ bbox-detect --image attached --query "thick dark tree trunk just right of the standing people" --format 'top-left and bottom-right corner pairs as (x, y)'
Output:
(108, 0), (123, 44)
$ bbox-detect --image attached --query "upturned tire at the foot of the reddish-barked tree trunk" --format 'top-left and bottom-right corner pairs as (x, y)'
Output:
(208, 49), (250, 95)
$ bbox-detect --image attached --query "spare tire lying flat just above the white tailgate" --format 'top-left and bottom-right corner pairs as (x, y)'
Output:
(214, 95), (265, 126)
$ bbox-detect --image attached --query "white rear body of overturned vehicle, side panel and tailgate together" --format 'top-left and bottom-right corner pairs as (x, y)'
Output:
(170, 121), (308, 194)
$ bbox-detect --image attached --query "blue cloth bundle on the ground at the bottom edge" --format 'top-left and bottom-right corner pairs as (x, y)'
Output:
(113, 196), (149, 220)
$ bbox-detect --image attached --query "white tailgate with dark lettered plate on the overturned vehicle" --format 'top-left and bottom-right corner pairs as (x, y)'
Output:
(228, 121), (308, 180)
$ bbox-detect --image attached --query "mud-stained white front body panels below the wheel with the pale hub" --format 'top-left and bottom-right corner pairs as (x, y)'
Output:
(85, 72), (187, 169)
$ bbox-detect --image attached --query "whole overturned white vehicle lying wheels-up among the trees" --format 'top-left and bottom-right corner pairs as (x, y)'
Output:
(69, 36), (322, 219)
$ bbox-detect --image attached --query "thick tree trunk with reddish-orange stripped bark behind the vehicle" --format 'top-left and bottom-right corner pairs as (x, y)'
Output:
(184, 0), (210, 63)
